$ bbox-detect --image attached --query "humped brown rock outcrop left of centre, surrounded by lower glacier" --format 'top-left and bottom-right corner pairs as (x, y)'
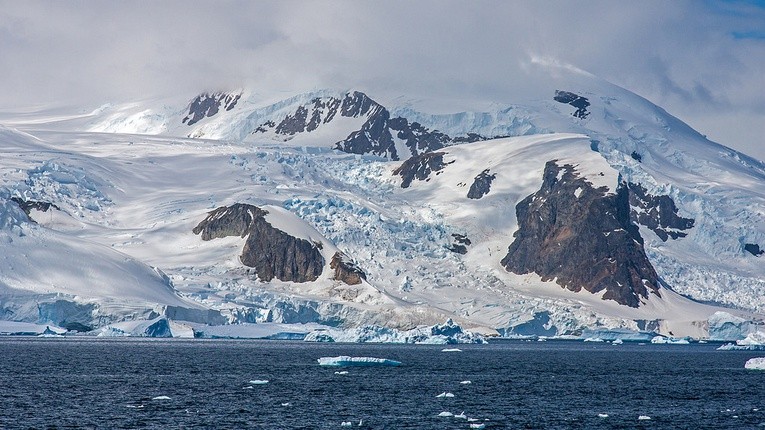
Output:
(193, 203), (324, 282)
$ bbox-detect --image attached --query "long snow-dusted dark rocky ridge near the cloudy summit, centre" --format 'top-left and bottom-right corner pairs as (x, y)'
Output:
(253, 91), (460, 160)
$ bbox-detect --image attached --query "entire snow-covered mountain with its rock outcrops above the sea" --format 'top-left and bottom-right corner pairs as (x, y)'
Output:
(0, 66), (765, 337)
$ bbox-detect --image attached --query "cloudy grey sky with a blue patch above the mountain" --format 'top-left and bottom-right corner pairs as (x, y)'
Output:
(0, 0), (765, 160)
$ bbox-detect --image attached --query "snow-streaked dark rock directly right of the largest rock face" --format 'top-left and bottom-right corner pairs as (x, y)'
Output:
(627, 183), (694, 242)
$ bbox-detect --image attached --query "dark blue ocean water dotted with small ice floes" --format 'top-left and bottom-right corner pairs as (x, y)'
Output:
(0, 338), (765, 429)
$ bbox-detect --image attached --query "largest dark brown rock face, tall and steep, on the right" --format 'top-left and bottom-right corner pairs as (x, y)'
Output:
(501, 161), (660, 307)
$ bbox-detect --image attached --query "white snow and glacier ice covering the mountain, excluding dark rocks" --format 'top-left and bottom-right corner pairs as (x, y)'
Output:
(0, 65), (765, 340)
